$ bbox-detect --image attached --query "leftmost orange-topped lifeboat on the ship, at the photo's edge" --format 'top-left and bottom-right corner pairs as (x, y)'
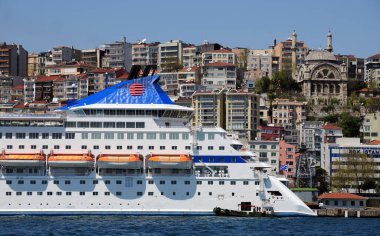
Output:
(0, 151), (46, 166)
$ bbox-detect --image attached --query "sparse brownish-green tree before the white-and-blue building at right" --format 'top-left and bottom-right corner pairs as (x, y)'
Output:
(332, 150), (375, 193)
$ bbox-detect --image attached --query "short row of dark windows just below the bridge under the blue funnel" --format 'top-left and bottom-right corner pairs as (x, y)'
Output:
(64, 121), (145, 129)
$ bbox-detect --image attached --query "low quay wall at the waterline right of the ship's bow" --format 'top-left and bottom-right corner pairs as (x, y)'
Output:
(316, 208), (380, 218)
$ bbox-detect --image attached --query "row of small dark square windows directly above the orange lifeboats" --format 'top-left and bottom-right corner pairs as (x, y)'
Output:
(7, 145), (224, 150)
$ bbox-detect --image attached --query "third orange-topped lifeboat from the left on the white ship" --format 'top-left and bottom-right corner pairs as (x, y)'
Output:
(97, 154), (142, 169)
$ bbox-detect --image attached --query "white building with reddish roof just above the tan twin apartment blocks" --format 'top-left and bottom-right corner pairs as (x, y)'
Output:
(202, 62), (236, 90)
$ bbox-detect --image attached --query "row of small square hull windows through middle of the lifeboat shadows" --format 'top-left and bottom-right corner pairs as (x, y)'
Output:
(6, 180), (260, 185)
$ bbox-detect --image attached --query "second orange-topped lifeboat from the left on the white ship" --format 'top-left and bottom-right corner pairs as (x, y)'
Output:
(48, 153), (94, 167)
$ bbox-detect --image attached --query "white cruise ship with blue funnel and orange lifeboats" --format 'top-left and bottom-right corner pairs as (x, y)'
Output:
(0, 75), (315, 216)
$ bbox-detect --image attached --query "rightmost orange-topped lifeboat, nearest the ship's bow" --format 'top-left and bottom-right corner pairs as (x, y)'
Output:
(148, 154), (193, 169)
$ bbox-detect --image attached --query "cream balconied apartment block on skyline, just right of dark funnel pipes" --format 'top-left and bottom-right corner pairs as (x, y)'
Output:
(158, 40), (186, 72)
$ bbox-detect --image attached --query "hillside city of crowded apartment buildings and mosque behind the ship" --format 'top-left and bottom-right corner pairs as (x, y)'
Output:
(0, 31), (380, 197)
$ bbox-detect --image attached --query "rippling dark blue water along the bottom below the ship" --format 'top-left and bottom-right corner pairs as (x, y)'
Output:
(0, 216), (380, 236)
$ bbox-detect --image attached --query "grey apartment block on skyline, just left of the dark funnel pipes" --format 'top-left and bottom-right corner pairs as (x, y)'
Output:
(102, 37), (132, 71)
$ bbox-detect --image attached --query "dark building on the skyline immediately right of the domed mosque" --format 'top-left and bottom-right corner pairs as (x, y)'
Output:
(335, 54), (365, 81)
